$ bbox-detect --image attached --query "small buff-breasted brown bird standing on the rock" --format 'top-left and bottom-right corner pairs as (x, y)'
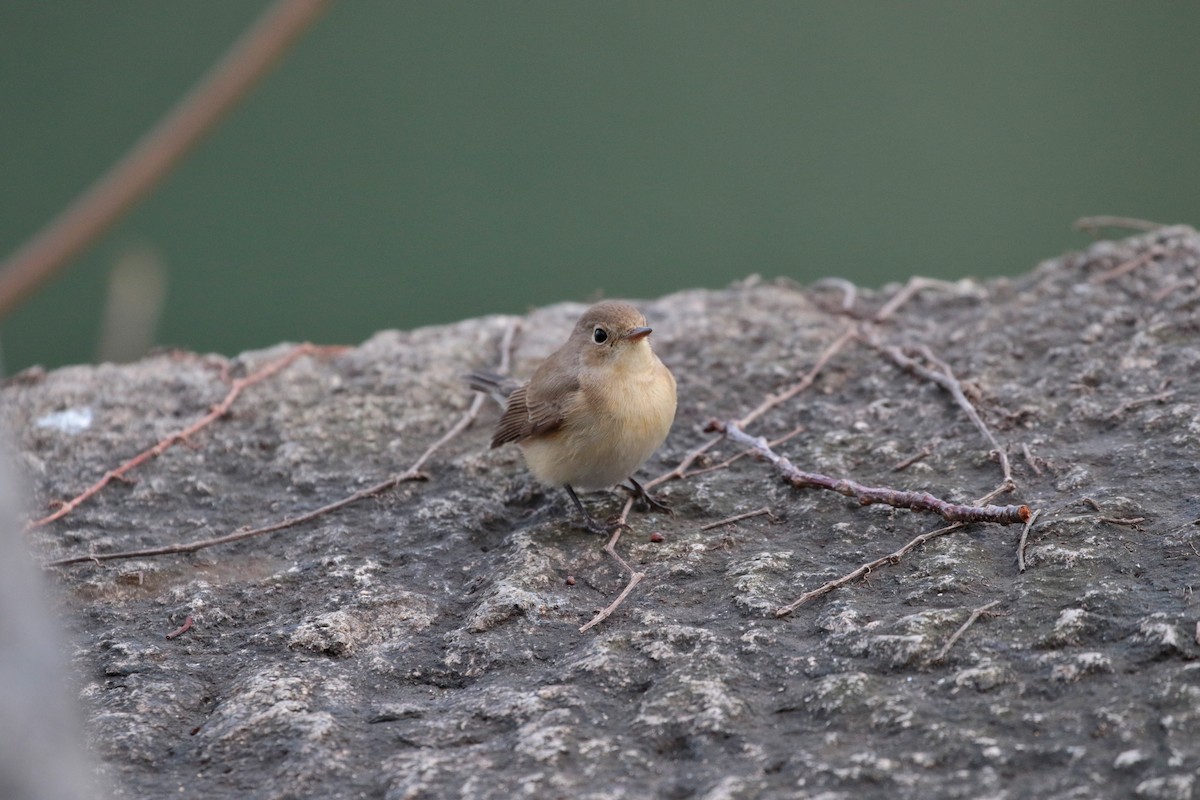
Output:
(467, 301), (676, 533)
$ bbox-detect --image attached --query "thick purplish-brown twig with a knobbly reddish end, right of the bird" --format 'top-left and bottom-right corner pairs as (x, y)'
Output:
(708, 420), (1031, 525)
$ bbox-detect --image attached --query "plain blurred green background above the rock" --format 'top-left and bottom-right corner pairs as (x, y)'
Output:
(0, 0), (1200, 372)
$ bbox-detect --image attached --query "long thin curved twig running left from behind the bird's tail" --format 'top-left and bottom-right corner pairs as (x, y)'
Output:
(43, 323), (520, 567)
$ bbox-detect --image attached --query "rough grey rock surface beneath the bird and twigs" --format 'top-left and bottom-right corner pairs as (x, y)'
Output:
(7, 228), (1200, 800)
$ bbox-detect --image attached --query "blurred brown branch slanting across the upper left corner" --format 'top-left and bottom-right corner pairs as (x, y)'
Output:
(0, 0), (329, 319)
